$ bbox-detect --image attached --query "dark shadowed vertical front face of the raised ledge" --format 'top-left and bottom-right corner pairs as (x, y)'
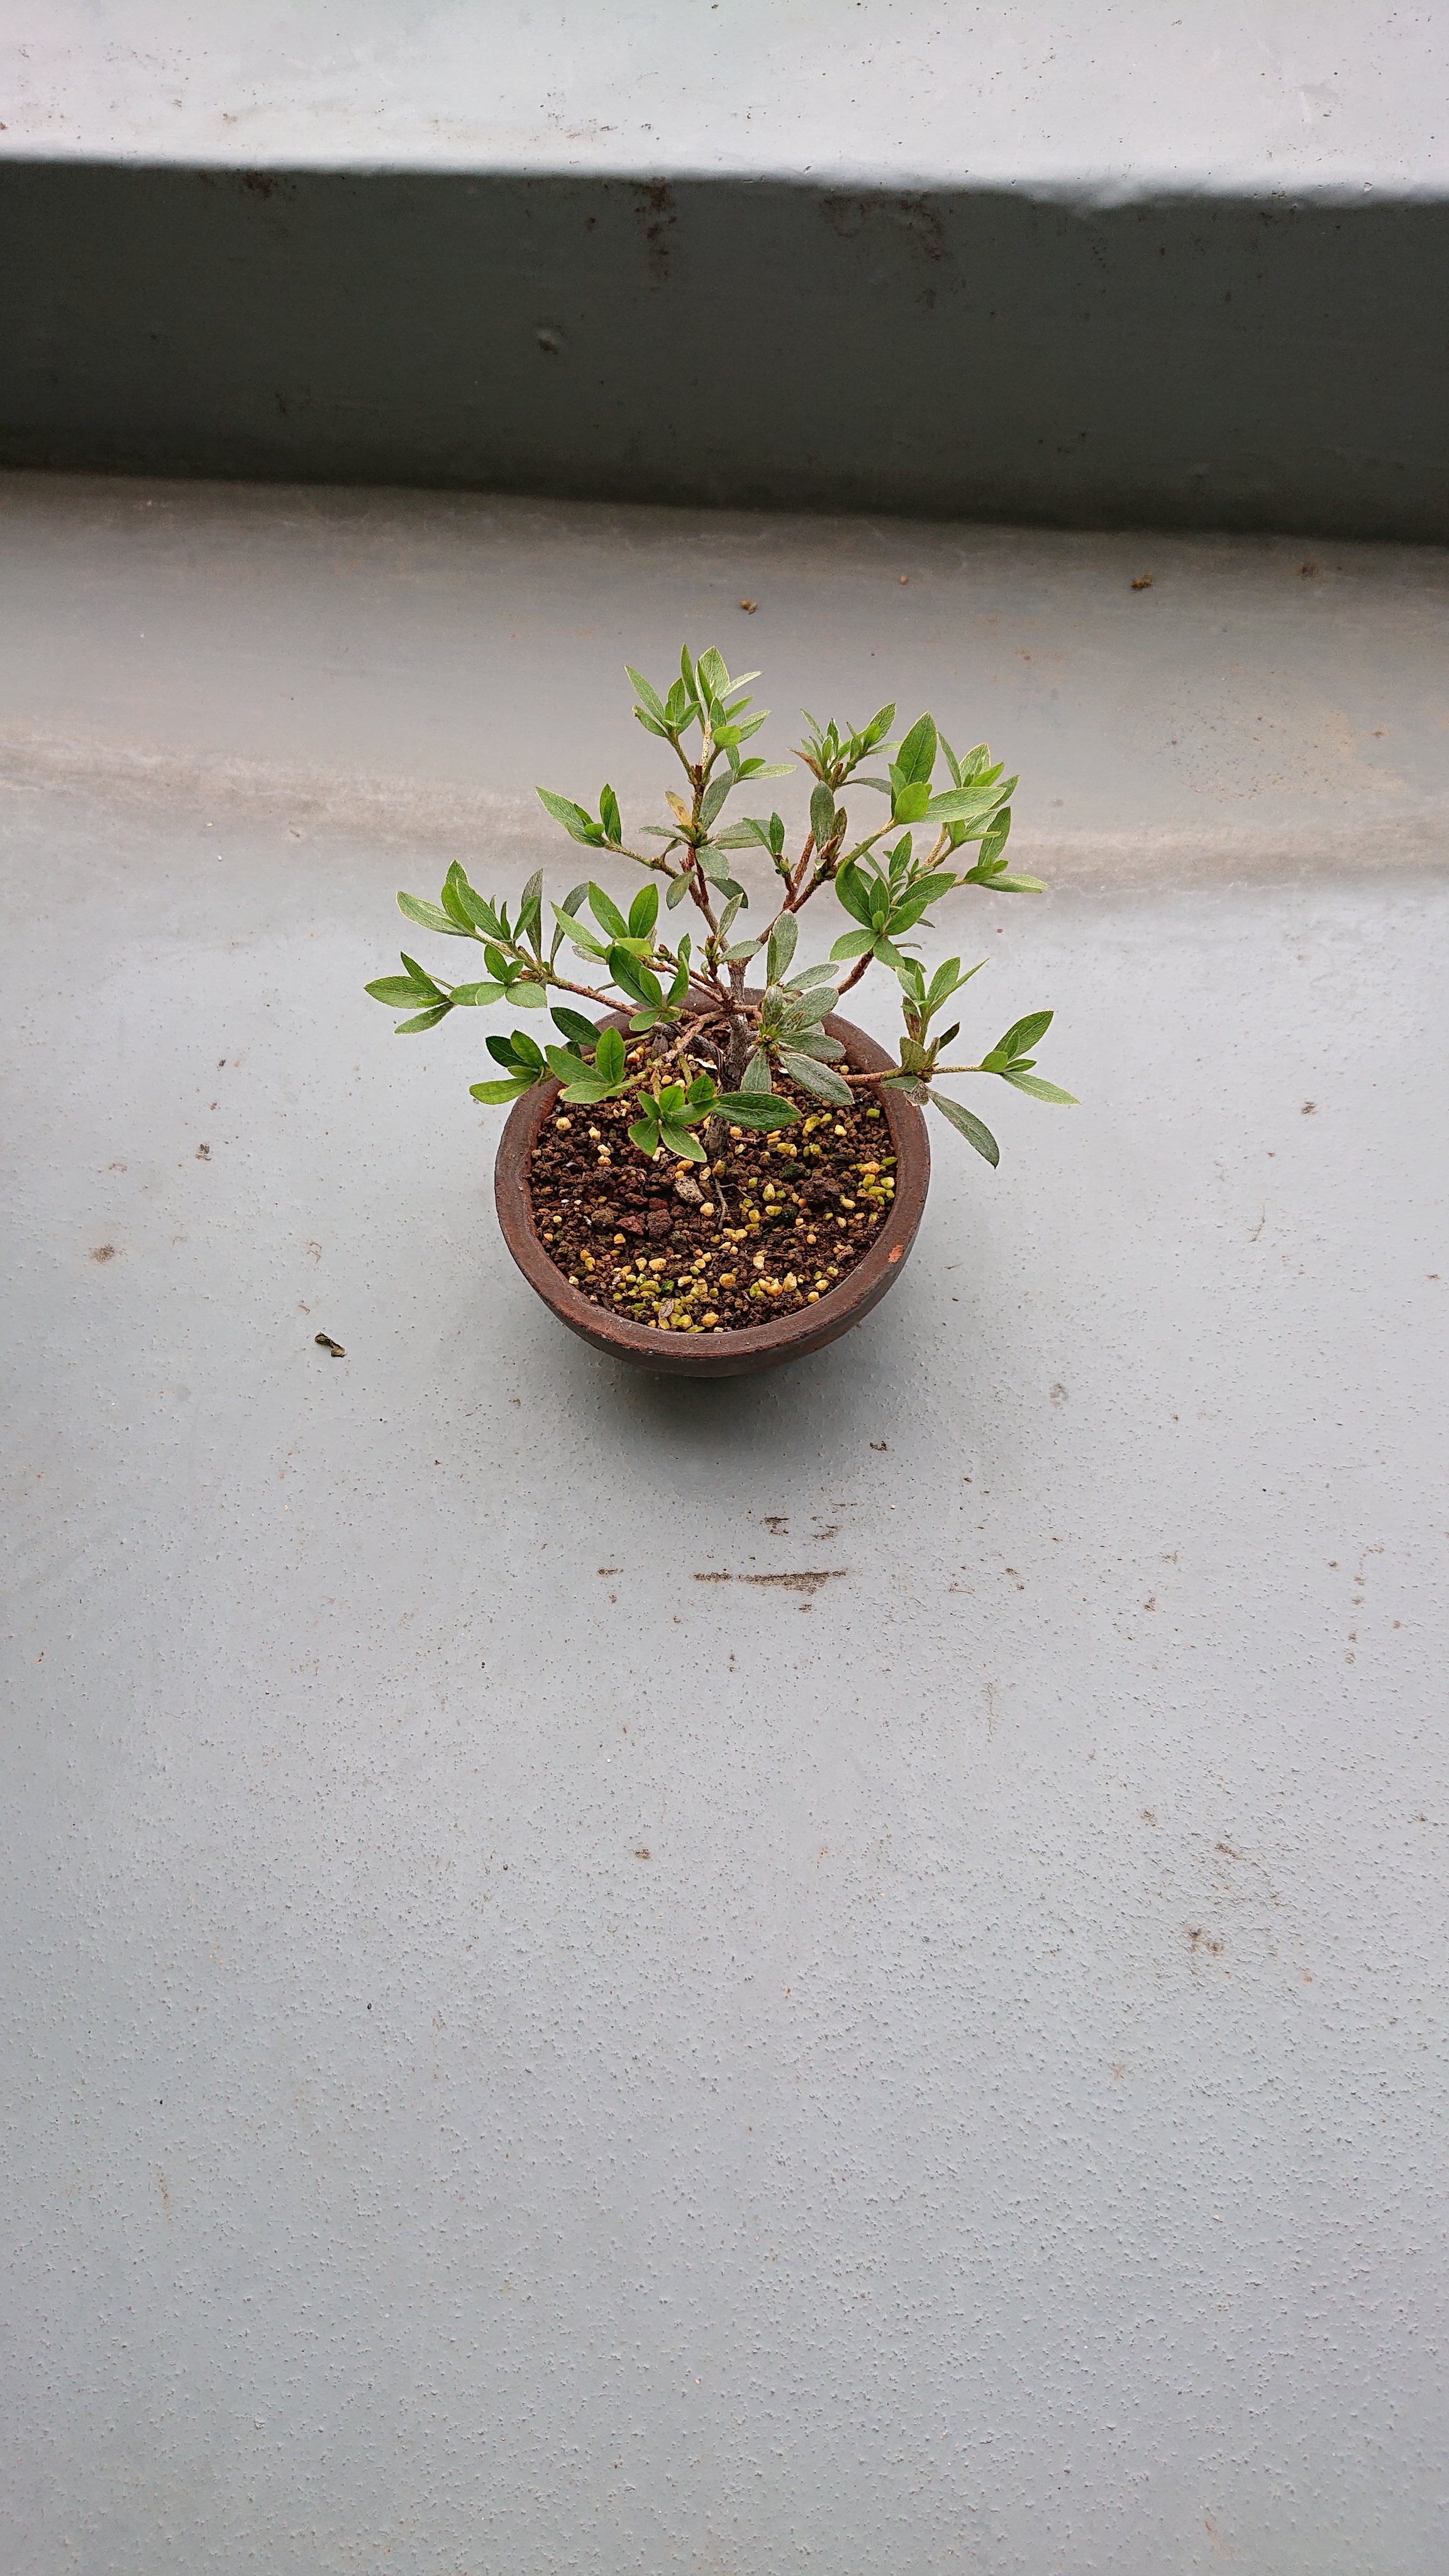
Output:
(0, 160), (1449, 541)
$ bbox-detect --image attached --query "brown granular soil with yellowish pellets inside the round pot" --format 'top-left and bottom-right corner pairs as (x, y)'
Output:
(528, 1082), (895, 1332)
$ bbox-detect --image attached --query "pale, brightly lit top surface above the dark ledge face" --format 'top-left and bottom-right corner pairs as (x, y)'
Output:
(0, 0), (1449, 198)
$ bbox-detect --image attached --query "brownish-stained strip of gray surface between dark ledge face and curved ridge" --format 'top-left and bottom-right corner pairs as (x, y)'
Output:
(0, 474), (1449, 886)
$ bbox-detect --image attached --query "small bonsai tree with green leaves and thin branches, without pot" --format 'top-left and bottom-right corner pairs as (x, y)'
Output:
(366, 647), (1072, 1179)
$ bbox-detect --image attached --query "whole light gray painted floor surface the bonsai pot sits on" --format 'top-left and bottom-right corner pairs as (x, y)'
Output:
(0, 482), (1449, 2576)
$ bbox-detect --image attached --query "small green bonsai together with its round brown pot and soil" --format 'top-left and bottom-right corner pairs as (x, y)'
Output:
(366, 649), (1072, 1375)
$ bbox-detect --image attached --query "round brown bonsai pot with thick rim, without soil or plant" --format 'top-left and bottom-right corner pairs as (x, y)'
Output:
(492, 1015), (931, 1378)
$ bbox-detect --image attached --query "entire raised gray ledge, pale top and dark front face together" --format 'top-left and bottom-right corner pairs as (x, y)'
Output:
(0, 0), (1449, 541)
